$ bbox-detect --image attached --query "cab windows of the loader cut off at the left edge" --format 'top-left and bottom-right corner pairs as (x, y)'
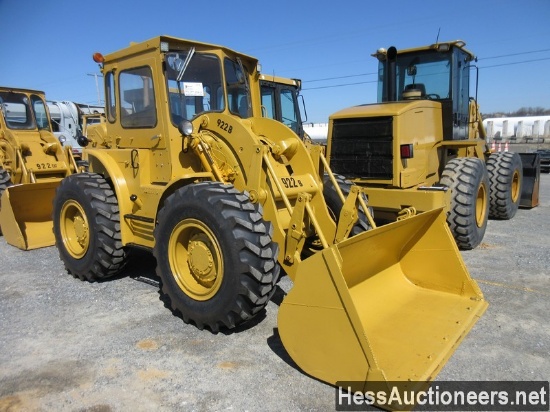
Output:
(0, 91), (50, 130)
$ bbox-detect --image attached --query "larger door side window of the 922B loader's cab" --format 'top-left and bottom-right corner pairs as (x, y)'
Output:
(119, 67), (157, 128)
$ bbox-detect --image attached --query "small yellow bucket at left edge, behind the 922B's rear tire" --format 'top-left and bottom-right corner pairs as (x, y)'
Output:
(0, 180), (60, 250)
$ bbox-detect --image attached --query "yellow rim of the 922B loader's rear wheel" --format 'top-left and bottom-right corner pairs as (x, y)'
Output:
(60, 200), (90, 259)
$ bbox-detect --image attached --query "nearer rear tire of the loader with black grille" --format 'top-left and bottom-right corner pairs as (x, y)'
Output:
(440, 157), (489, 250)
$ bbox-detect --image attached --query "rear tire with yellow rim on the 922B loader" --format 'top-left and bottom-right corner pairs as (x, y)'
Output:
(53, 173), (127, 282)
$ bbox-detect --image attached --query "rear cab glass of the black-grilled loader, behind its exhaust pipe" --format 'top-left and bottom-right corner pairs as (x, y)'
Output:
(378, 50), (452, 102)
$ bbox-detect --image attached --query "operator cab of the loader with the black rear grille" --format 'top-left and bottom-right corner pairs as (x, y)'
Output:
(373, 40), (476, 140)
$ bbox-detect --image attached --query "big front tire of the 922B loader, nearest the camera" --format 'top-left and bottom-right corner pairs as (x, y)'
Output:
(153, 182), (280, 333)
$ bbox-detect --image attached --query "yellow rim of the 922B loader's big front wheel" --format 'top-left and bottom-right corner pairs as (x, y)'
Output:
(168, 219), (223, 301)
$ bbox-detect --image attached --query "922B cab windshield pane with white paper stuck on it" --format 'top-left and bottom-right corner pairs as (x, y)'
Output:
(165, 49), (225, 125)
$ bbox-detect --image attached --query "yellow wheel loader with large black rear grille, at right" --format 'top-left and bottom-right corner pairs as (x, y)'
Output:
(327, 40), (530, 249)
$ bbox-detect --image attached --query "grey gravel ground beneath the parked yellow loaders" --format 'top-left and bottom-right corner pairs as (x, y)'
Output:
(0, 174), (550, 412)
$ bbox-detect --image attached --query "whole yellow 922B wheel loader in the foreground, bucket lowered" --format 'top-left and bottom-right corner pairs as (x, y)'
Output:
(54, 36), (487, 406)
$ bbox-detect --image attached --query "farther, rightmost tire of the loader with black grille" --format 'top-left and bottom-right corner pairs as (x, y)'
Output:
(487, 152), (523, 220)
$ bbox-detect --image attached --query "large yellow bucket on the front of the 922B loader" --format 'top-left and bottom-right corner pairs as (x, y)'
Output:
(278, 209), (488, 408)
